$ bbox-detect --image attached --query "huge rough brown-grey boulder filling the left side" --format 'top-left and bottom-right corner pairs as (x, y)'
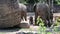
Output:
(0, 0), (21, 28)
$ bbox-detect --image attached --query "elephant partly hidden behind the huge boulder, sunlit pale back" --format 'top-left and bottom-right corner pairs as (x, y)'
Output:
(19, 3), (27, 20)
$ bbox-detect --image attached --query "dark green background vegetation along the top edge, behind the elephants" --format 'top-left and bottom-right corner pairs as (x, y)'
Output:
(19, 0), (60, 5)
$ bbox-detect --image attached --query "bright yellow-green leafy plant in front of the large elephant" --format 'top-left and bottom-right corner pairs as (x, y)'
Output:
(37, 16), (46, 34)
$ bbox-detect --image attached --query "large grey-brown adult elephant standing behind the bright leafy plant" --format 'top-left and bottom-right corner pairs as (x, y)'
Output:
(34, 3), (52, 27)
